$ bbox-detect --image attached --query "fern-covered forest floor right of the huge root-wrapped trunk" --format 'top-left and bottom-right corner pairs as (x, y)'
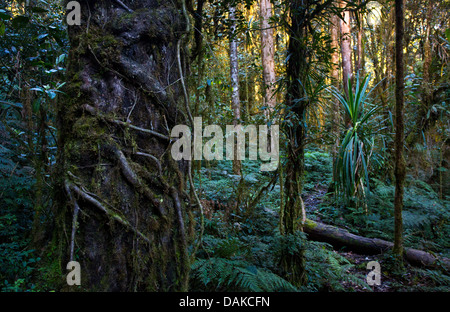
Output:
(194, 149), (450, 292)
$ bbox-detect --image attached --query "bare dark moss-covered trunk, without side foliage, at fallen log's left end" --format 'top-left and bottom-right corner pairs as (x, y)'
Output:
(280, 1), (309, 285)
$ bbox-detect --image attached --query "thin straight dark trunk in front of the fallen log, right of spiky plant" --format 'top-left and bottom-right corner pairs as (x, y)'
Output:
(393, 0), (406, 256)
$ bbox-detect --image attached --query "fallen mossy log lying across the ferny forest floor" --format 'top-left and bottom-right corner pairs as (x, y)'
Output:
(303, 219), (450, 270)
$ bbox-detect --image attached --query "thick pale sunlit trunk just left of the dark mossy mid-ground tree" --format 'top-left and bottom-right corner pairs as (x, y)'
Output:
(260, 0), (276, 116)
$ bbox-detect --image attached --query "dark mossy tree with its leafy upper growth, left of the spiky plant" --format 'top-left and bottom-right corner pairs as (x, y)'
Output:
(280, 0), (332, 285)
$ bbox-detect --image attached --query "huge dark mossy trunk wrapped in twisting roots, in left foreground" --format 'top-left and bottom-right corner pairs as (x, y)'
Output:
(50, 0), (189, 291)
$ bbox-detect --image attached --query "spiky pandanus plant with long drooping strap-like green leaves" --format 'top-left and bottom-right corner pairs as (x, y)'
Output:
(331, 76), (381, 205)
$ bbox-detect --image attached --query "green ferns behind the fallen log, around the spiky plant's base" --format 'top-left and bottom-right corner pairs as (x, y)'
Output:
(316, 177), (450, 257)
